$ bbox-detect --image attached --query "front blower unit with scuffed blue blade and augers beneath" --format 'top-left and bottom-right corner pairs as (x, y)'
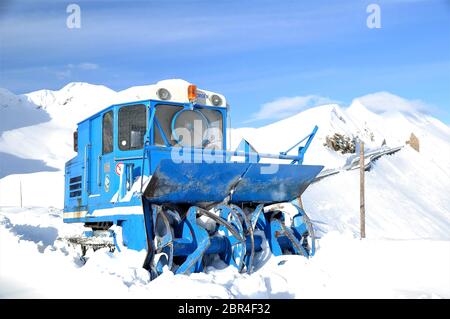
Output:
(143, 160), (321, 277)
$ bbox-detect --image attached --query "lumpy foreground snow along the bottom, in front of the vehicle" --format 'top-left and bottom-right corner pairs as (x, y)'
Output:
(0, 208), (450, 298)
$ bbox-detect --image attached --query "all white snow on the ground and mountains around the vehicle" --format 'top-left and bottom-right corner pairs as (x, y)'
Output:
(0, 83), (450, 298)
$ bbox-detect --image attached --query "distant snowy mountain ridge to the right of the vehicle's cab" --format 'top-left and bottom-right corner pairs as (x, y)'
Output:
(231, 99), (450, 170)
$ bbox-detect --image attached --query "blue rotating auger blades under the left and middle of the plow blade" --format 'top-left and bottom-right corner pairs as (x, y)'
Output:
(144, 204), (262, 278)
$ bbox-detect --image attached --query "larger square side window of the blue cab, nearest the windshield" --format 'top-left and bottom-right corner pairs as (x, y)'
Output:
(118, 104), (147, 151)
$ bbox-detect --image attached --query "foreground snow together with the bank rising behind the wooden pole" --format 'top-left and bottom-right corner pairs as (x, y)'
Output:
(0, 148), (450, 298)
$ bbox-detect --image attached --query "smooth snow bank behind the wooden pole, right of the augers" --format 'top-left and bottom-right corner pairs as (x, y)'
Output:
(303, 147), (450, 240)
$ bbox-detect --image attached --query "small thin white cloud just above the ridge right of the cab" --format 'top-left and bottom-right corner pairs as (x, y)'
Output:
(245, 95), (337, 123)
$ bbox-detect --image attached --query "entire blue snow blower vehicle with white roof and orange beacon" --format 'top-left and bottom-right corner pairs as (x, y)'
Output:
(64, 80), (323, 278)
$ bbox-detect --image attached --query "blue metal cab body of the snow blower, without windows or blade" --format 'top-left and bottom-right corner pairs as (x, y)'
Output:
(64, 100), (227, 250)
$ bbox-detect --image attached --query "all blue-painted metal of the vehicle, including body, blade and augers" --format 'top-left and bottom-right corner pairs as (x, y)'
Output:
(64, 91), (323, 278)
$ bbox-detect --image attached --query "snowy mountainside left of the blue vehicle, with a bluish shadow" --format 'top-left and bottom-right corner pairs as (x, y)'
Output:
(0, 79), (197, 207)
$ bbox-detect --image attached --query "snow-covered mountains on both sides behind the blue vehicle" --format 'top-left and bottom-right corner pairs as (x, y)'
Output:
(0, 80), (450, 216)
